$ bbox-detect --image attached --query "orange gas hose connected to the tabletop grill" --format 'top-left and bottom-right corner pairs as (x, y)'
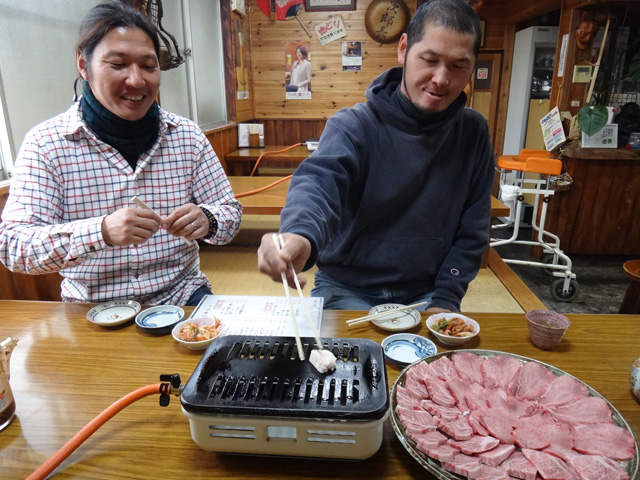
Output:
(27, 383), (171, 480)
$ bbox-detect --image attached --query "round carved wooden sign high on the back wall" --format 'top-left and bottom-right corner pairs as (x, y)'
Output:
(364, 0), (411, 43)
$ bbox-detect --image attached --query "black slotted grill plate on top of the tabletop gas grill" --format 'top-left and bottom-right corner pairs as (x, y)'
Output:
(181, 335), (388, 419)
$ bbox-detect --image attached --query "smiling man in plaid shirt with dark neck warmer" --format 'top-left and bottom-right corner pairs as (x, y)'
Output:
(0, 3), (242, 305)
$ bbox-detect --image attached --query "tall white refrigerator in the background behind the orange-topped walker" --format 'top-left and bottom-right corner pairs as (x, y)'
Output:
(503, 27), (558, 155)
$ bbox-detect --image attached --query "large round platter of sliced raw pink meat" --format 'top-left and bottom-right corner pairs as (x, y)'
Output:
(390, 349), (640, 480)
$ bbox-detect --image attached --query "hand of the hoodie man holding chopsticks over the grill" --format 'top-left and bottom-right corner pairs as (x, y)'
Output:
(258, 233), (311, 288)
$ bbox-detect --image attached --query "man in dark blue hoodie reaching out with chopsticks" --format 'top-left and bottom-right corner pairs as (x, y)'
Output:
(258, 0), (495, 312)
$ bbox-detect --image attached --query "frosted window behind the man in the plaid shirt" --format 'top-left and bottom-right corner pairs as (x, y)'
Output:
(0, 0), (226, 180)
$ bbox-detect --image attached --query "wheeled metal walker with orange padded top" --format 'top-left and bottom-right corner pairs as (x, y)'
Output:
(489, 149), (580, 302)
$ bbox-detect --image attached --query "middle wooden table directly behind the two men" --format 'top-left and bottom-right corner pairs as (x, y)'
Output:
(229, 176), (509, 217)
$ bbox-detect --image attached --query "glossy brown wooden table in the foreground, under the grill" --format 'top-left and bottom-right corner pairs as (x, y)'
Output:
(0, 301), (640, 480)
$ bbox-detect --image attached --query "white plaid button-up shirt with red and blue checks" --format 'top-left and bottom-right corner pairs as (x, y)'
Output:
(0, 103), (242, 305)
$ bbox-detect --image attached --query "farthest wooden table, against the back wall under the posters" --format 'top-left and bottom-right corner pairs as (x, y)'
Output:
(224, 145), (311, 175)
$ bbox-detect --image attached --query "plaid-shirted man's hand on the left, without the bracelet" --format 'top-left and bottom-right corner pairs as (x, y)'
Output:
(102, 208), (162, 246)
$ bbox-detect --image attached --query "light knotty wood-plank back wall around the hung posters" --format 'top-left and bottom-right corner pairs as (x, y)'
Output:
(248, 0), (507, 120)
